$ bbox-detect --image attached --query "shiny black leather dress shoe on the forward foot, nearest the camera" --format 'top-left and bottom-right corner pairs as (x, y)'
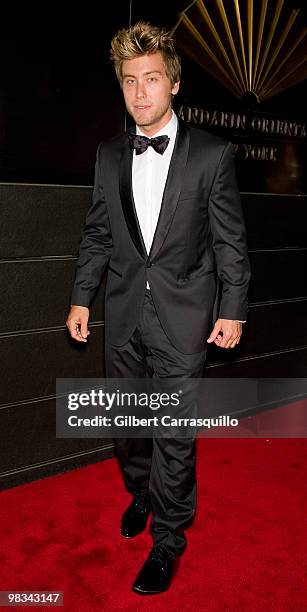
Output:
(132, 544), (179, 595)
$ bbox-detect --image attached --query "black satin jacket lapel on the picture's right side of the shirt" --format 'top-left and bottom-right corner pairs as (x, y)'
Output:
(149, 119), (190, 261)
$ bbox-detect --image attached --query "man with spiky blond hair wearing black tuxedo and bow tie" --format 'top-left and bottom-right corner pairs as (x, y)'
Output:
(66, 22), (250, 594)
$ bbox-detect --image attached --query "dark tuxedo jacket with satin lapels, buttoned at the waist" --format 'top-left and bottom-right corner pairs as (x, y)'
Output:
(71, 119), (250, 353)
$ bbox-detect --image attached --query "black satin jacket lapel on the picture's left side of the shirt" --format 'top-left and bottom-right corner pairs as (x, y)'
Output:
(119, 128), (147, 259)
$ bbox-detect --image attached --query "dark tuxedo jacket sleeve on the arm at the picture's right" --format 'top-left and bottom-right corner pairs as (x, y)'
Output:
(208, 142), (251, 320)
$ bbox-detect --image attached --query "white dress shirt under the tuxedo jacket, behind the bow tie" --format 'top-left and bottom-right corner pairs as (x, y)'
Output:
(132, 110), (245, 323)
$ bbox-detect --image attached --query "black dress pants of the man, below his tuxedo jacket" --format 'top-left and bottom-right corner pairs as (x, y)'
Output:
(105, 289), (206, 555)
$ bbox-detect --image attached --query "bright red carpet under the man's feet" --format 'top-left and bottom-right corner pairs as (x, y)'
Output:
(0, 439), (307, 612)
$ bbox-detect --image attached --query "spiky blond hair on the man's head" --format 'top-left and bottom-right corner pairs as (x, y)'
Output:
(110, 21), (181, 87)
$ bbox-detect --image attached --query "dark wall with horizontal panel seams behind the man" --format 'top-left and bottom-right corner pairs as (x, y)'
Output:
(0, 0), (307, 486)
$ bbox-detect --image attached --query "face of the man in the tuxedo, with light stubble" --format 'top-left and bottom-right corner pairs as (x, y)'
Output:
(122, 51), (179, 136)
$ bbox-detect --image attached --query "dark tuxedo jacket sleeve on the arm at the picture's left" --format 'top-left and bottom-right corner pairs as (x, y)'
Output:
(70, 143), (113, 307)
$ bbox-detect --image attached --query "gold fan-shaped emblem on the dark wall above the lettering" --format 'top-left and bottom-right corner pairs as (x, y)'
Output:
(173, 0), (307, 102)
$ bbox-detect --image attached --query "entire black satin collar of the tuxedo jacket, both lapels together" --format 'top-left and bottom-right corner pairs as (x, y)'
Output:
(120, 119), (190, 261)
